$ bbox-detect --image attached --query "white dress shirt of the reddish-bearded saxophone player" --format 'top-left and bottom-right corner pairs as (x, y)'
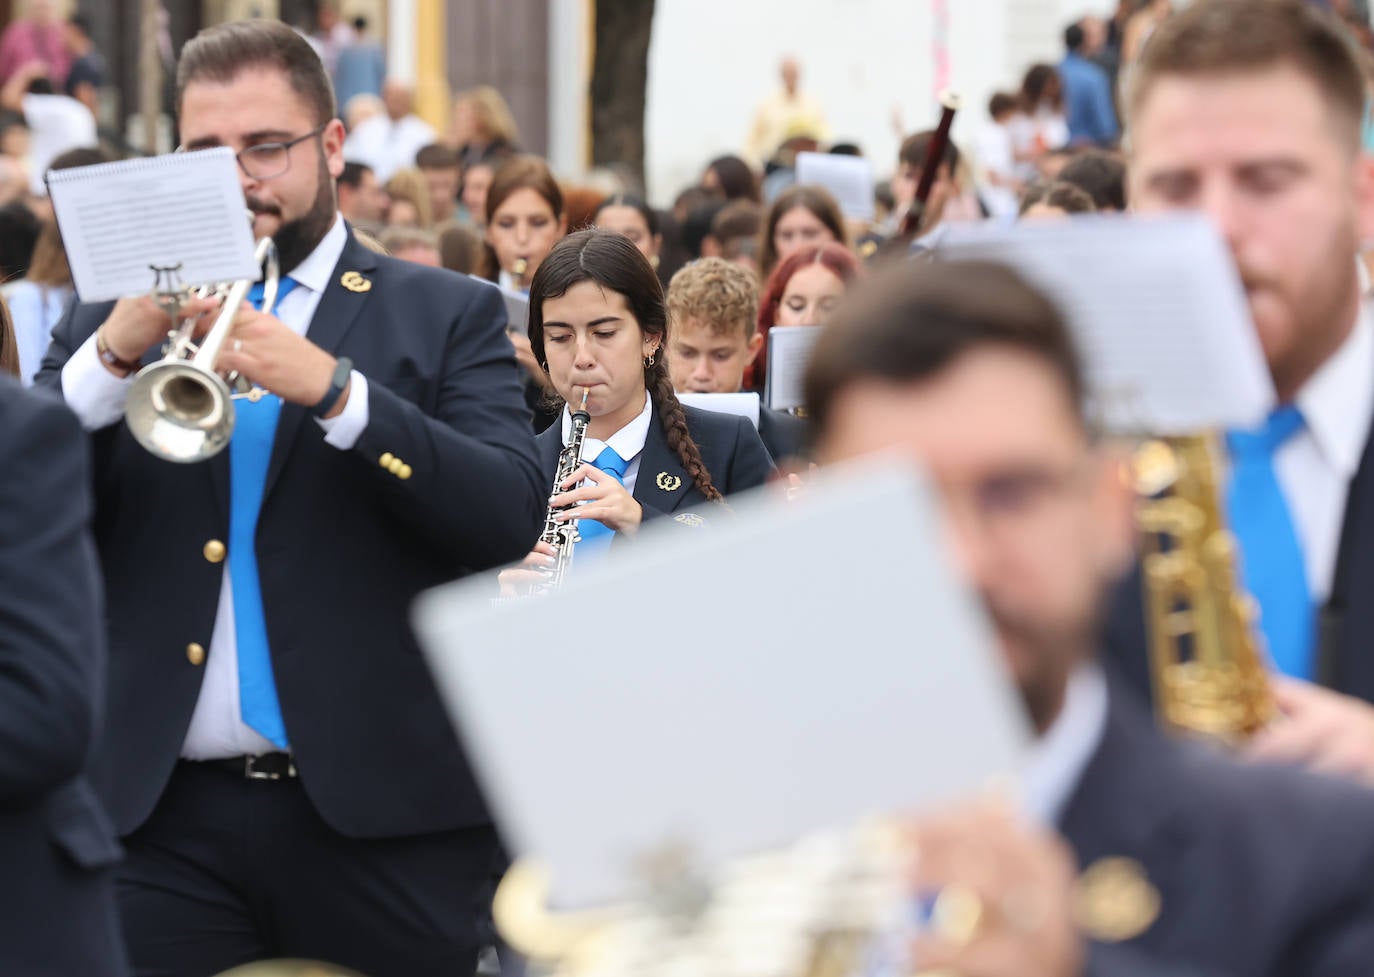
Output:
(1274, 308), (1374, 605)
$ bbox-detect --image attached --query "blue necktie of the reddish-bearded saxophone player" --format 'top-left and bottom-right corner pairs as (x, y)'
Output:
(1226, 405), (1315, 679)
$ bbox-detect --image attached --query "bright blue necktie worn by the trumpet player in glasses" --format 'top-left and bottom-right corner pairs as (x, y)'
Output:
(229, 278), (295, 749)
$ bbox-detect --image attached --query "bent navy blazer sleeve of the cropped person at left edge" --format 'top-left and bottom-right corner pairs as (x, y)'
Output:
(0, 379), (103, 807)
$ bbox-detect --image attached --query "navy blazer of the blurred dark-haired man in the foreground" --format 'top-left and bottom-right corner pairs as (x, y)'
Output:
(1059, 687), (1374, 977)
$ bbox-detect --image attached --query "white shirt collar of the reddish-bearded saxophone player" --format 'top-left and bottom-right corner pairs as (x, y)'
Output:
(1296, 304), (1374, 478)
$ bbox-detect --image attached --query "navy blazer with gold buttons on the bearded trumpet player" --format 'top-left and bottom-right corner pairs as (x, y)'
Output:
(38, 234), (548, 837)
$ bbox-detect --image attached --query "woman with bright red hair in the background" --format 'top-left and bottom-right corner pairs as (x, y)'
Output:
(745, 240), (861, 390)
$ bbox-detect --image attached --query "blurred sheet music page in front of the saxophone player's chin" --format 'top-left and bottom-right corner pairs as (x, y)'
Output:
(936, 216), (1276, 434)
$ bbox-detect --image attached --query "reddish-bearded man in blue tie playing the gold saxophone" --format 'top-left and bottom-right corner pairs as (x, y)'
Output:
(1107, 0), (1374, 783)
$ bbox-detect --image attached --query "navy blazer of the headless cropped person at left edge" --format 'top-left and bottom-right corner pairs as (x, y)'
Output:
(0, 377), (126, 977)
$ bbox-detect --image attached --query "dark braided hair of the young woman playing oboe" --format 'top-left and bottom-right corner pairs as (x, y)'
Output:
(529, 227), (724, 502)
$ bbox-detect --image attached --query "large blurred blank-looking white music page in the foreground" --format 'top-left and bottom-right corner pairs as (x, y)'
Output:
(415, 462), (1029, 907)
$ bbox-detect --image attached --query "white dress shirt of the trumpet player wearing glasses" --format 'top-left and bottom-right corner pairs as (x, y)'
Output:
(62, 217), (368, 760)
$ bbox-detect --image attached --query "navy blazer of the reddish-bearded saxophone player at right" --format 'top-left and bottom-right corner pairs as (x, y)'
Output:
(1103, 403), (1374, 702)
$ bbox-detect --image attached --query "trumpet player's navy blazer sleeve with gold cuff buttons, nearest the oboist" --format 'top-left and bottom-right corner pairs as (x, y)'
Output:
(346, 274), (544, 568)
